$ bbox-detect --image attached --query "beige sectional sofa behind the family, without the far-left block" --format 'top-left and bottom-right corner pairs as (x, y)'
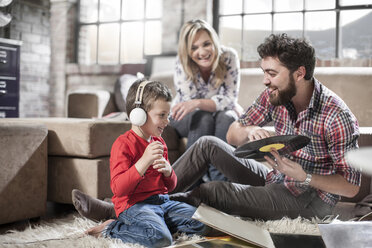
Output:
(0, 68), (372, 223)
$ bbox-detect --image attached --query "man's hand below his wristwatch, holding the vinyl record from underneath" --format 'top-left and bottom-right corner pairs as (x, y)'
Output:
(264, 148), (306, 182)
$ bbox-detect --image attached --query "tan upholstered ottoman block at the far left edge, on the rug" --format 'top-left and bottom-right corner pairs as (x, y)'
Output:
(0, 120), (48, 224)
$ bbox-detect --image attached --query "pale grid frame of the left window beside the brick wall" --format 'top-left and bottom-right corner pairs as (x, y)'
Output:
(75, 0), (162, 65)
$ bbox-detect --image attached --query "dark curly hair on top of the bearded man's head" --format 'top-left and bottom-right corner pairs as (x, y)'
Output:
(257, 33), (316, 80)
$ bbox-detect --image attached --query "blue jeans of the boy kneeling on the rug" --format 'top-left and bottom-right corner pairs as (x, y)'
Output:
(104, 195), (209, 247)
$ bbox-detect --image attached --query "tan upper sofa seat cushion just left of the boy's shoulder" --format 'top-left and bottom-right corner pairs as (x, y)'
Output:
(8, 117), (131, 158)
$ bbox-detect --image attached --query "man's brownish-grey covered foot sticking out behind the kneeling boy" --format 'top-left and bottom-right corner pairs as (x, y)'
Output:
(71, 189), (116, 221)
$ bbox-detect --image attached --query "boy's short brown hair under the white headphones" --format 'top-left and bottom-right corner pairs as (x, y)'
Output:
(126, 79), (172, 116)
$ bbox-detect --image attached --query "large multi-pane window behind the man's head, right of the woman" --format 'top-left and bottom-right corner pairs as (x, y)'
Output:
(214, 0), (372, 61)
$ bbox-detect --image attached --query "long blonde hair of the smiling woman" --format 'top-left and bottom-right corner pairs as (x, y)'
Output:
(178, 19), (226, 88)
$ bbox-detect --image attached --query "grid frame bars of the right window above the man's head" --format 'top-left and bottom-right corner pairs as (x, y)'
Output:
(213, 0), (372, 60)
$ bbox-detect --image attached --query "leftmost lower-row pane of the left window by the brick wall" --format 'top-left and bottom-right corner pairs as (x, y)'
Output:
(78, 25), (97, 65)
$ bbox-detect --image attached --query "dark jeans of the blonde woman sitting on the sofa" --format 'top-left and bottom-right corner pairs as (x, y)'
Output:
(170, 110), (238, 181)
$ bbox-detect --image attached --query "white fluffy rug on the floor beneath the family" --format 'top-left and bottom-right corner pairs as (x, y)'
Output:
(0, 214), (320, 248)
